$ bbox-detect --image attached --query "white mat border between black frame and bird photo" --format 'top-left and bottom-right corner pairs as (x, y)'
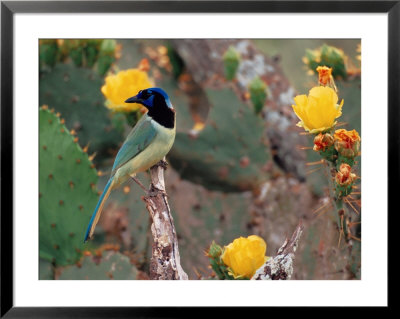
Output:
(14, 14), (388, 307)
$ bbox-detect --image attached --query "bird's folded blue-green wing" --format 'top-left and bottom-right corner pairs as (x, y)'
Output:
(111, 115), (157, 176)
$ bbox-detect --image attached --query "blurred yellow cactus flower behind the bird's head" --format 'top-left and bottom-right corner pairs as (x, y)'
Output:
(101, 69), (153, 112)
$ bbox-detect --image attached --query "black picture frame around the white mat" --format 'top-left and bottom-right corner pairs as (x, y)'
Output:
(0, 0), (394, 318)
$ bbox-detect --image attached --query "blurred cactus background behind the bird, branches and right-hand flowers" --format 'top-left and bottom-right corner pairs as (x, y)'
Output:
(39, 39), (361, 280)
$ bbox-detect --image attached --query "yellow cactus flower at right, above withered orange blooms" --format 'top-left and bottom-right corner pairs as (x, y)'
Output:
(292, 86), (343, 134)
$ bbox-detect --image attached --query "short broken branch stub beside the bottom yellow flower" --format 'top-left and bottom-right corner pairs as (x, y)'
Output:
(251, 221), (304, 280)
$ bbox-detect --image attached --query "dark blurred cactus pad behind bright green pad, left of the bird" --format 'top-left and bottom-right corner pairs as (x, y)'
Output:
(39, 63), (122, 159)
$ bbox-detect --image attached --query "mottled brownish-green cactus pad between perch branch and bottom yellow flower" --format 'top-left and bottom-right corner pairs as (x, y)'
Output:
(165, 169), (252, 279)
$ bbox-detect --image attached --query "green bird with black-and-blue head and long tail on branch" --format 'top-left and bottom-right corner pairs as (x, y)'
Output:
(84, 87), (176, 243)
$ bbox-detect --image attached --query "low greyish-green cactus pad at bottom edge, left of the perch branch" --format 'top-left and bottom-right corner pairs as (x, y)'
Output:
(58, 251), (138, 280)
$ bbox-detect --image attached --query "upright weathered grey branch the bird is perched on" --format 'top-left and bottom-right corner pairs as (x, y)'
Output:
(143, 162), (188, 280)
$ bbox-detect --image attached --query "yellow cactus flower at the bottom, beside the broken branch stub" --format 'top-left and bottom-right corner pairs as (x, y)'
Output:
(222, 235), (267, 279)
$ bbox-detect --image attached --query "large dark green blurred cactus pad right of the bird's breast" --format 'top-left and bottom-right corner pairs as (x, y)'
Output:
(168, 89), (271, 191)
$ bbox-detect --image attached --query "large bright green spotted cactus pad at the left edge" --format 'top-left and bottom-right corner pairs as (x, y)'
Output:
(39, 108), (98, 266)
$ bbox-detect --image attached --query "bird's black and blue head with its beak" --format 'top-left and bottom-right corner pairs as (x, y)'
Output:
(125, 88), (175, 128)
